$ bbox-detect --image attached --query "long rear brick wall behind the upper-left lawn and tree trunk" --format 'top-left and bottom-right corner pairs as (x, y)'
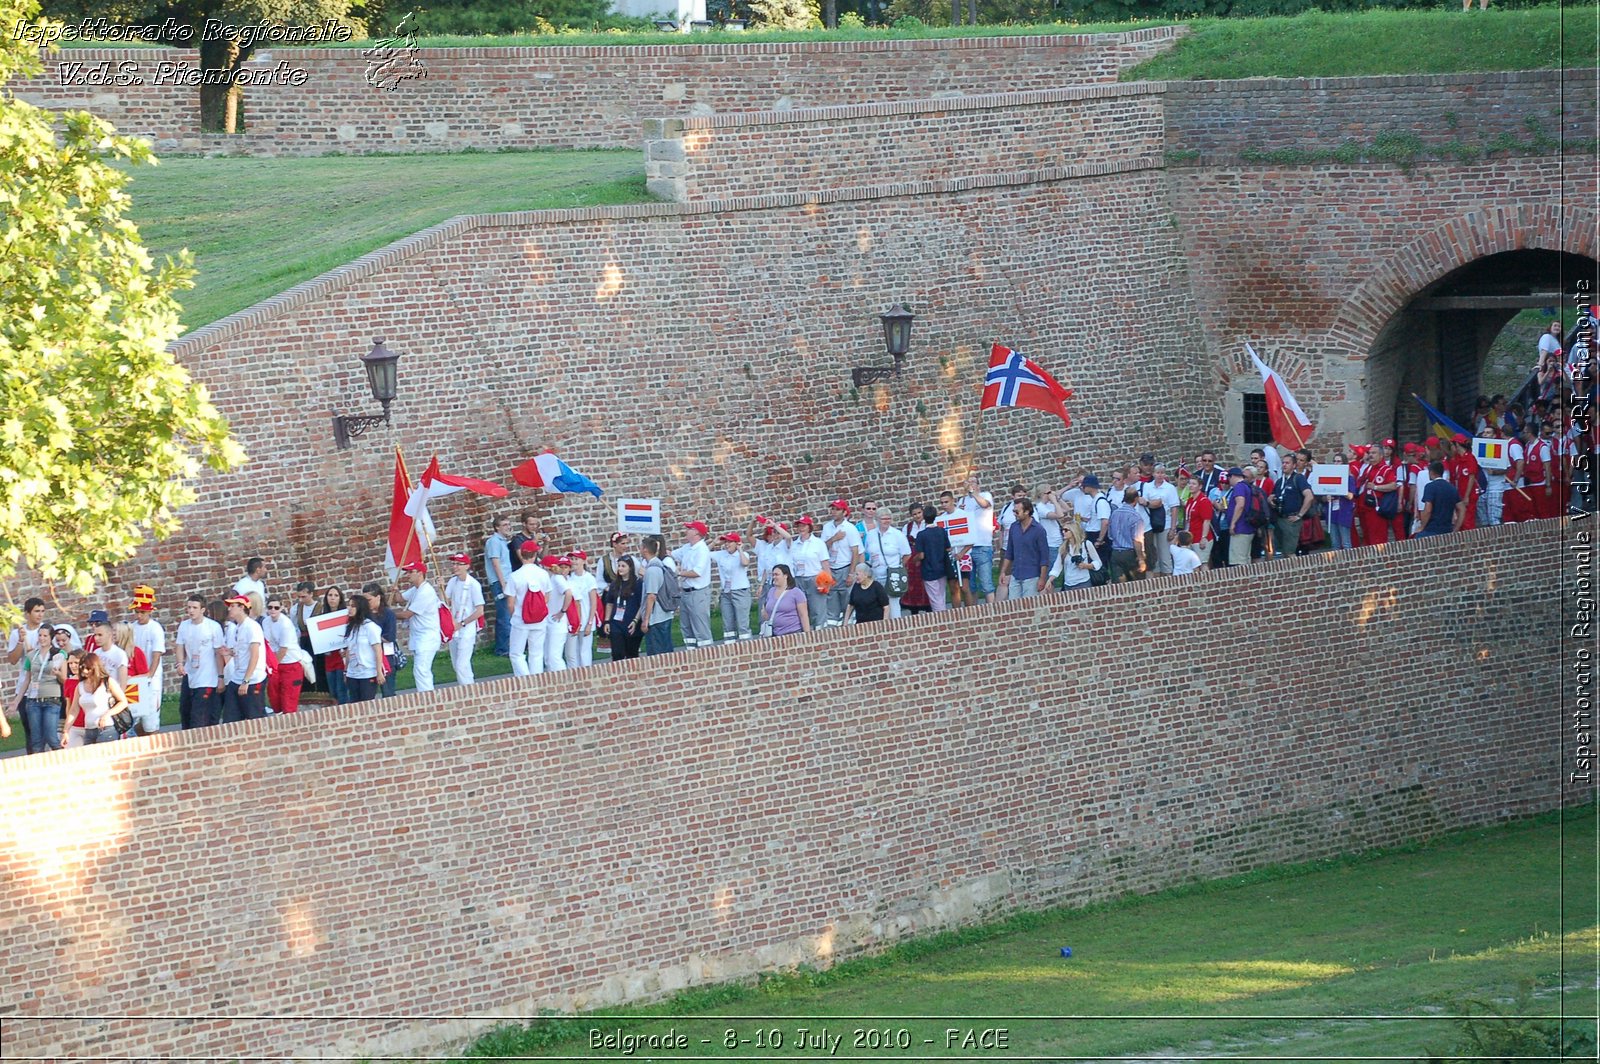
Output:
(13, 26), (1186, 155)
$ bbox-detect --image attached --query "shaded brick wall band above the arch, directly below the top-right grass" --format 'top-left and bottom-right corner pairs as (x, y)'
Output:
(1166, 69), (1595, 165)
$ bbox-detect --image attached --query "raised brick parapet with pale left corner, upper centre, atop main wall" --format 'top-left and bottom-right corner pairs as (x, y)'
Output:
(645, 83), (1162, 202)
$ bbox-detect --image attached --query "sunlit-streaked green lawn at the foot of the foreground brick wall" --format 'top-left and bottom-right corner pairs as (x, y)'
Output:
(467, 806), (1600, 1059)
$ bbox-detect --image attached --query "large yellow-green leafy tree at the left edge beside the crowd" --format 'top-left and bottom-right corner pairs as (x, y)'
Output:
(0, 0), (245, 614)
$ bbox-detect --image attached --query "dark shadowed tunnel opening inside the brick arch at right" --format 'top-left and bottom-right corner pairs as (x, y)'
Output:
(1366, 250), (1600, 440)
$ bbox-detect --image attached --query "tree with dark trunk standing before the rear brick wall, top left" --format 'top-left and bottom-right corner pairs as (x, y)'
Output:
(38, 0), (365, 133)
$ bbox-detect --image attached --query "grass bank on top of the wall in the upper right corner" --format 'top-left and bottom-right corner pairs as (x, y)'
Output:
(1122, 3), (1597, 82)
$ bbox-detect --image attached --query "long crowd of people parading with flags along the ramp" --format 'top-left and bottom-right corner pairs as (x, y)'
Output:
(0, 320), (1600, 754)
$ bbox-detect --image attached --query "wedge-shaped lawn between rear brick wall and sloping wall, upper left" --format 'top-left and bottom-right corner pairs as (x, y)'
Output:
(128, 150), (648, 328)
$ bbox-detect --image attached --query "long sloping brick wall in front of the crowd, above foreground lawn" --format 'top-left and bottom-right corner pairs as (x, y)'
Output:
(0, 522), (1587, 1058)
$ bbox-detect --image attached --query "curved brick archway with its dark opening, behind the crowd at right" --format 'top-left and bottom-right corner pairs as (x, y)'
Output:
(1326, 203), (1600, 438)
